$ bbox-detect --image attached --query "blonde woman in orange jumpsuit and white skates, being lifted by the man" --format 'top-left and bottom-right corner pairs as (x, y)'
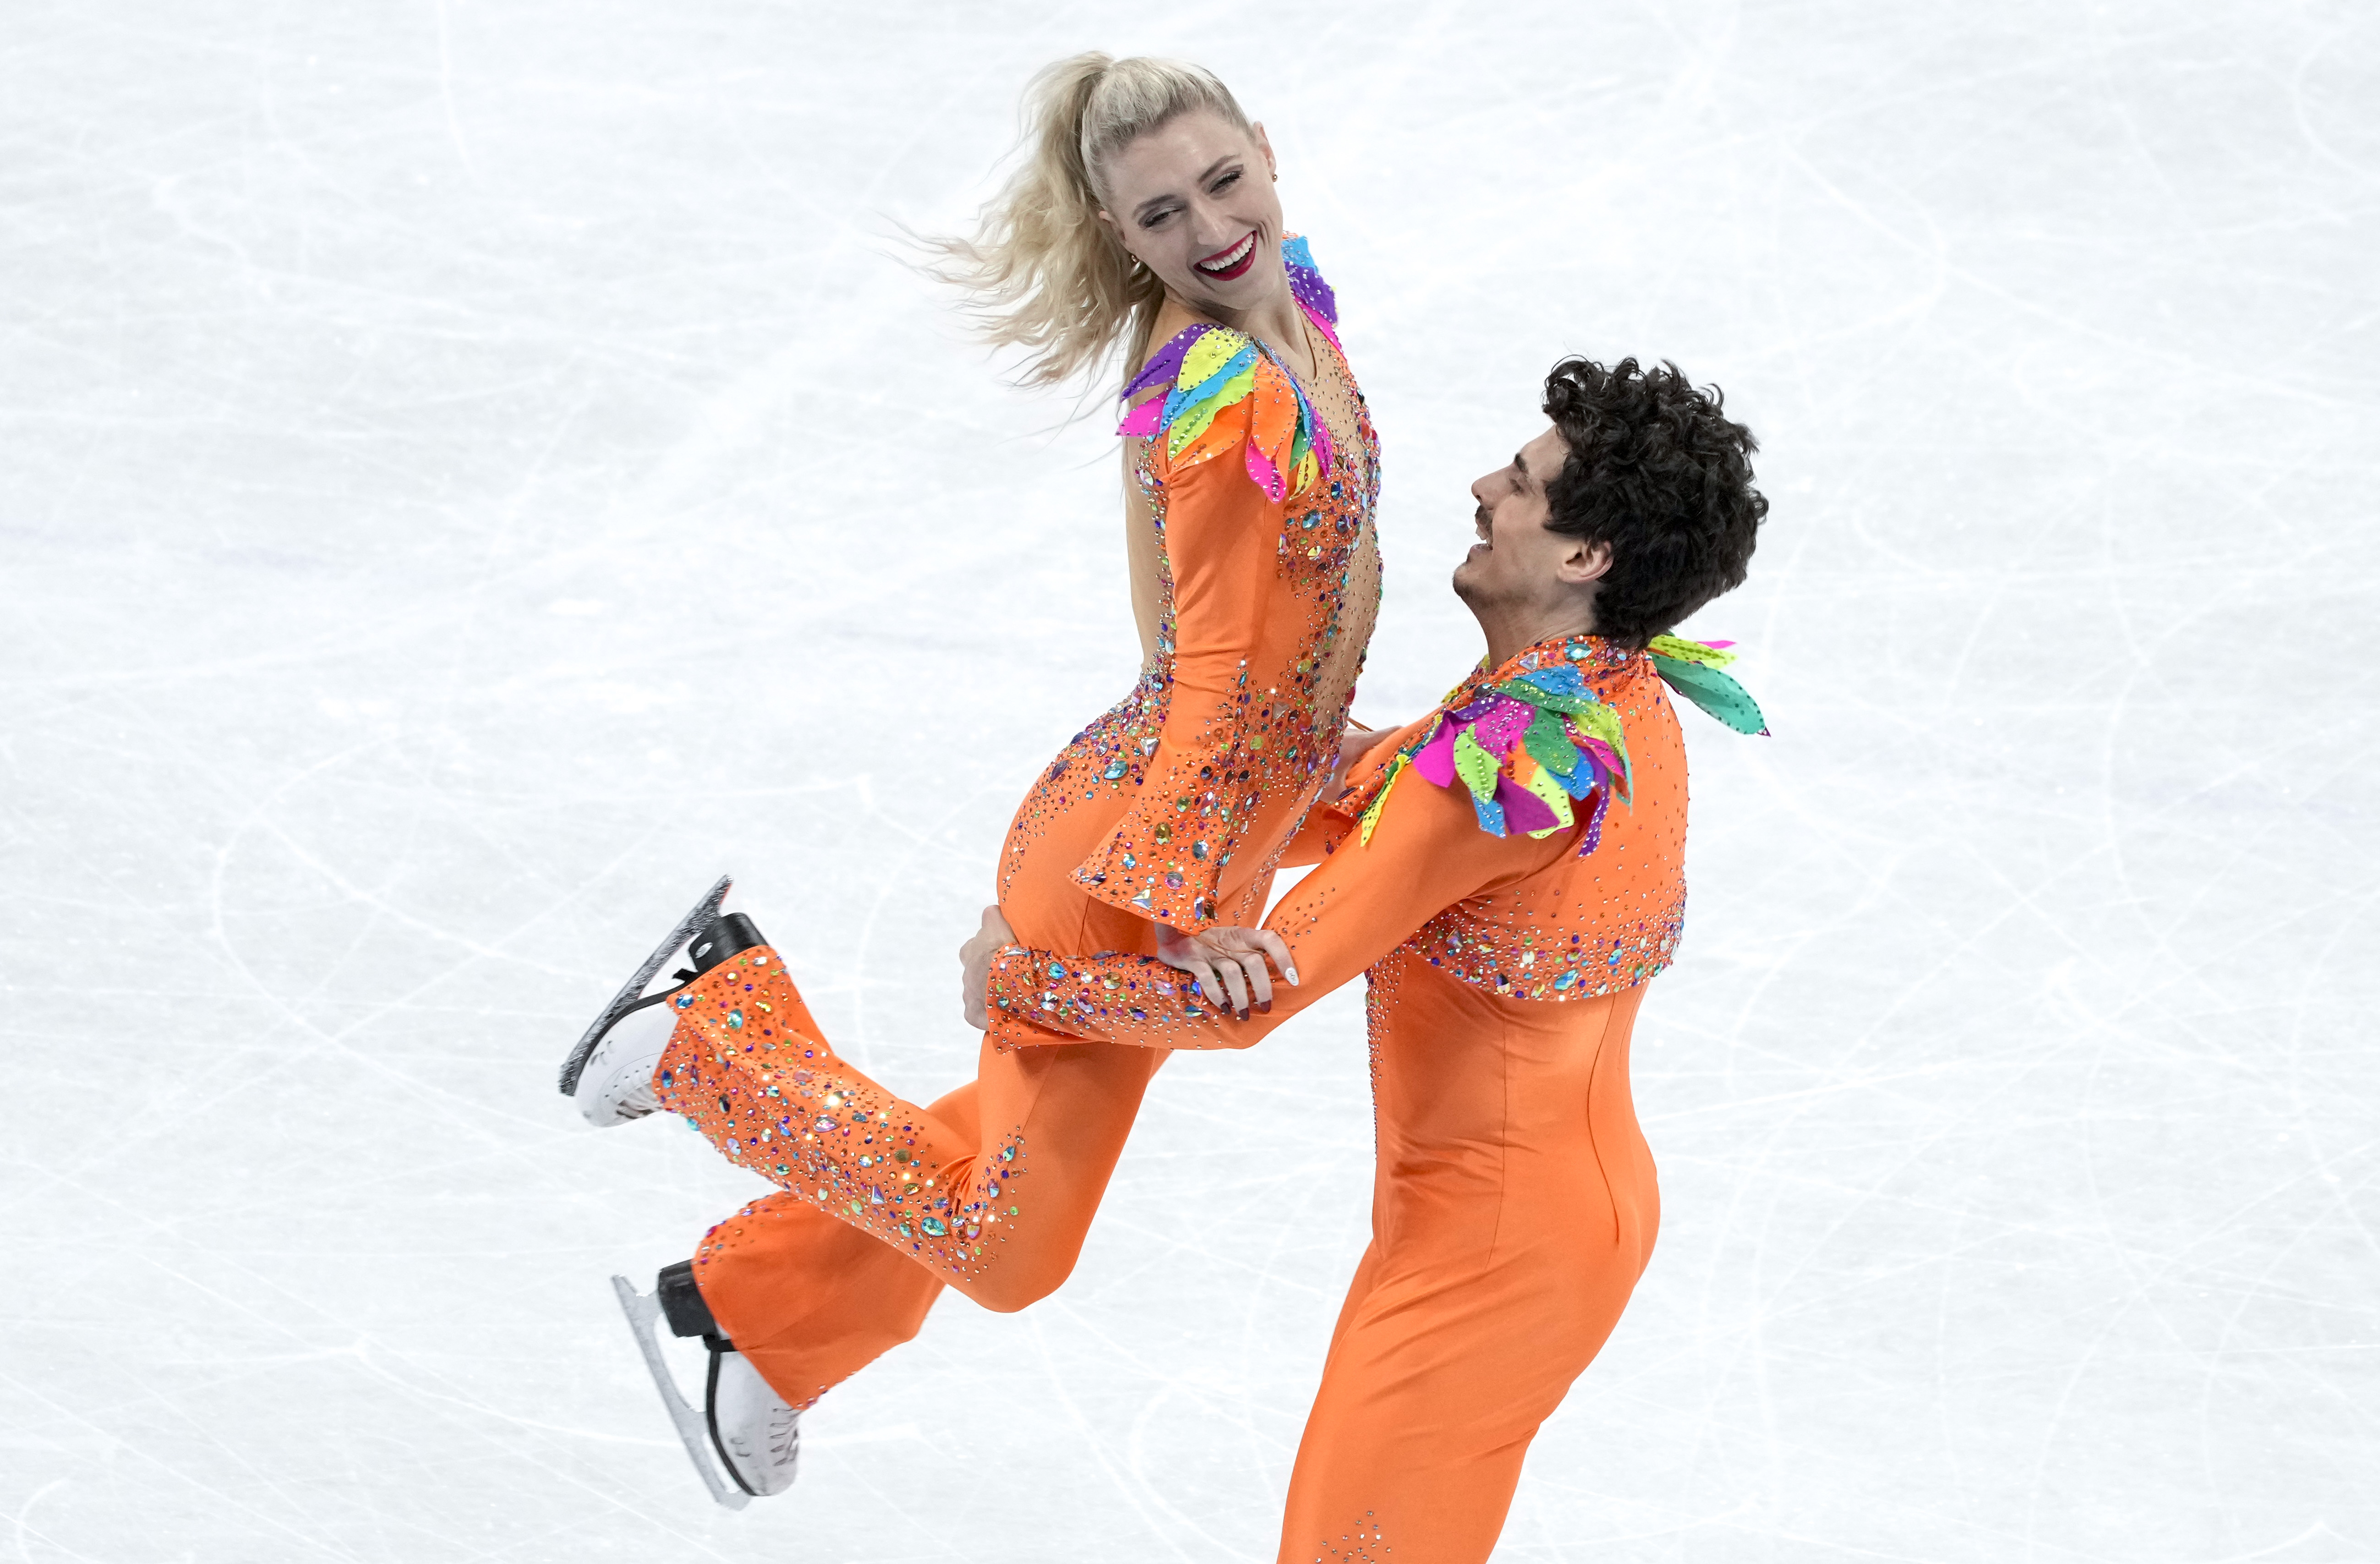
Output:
(562, 55), (1380, 1507)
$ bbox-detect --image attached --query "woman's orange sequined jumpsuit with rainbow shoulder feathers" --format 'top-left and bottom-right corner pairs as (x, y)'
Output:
(655, 241), (1380, 1407)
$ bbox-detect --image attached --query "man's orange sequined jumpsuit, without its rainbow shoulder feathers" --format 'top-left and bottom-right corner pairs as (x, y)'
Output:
(990, 635), (1685, 1564)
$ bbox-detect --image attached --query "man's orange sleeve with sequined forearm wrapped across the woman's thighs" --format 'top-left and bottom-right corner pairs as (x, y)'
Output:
(985, 757), (1576, 1047)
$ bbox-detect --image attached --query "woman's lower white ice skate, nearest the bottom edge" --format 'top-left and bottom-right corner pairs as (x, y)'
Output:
(612, 1266), (802, 1509)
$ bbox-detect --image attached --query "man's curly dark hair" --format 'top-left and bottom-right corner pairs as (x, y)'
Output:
(1545, 357), (1768, 647)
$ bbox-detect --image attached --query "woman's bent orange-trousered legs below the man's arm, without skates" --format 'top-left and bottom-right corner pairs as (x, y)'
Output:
(655, 945), (1166, 1405)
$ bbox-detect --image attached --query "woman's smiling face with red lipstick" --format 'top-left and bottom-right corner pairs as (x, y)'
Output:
(1100, 109), (1290, 317)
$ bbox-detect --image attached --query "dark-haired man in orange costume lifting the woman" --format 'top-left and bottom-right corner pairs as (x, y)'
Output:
(964, 360), (1766, 1564)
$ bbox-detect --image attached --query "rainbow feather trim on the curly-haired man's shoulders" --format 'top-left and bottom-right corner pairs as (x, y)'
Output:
(1340, 635), (1768, 857)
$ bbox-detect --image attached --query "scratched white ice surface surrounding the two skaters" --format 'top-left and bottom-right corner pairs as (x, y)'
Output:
(0, 0), (2380, 1564)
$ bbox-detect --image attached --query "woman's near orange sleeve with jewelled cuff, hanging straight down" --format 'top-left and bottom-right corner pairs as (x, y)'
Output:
(1076, 390), (1287, 931)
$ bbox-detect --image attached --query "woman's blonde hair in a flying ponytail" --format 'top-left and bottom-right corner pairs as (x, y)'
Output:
(928, 50), (1249, 386)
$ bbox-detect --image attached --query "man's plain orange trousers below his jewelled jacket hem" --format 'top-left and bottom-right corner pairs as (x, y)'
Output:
(1280, 952), (1659, 1564)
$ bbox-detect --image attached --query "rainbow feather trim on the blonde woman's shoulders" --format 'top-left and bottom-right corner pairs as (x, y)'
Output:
(1116, 238), (1338, 502)
